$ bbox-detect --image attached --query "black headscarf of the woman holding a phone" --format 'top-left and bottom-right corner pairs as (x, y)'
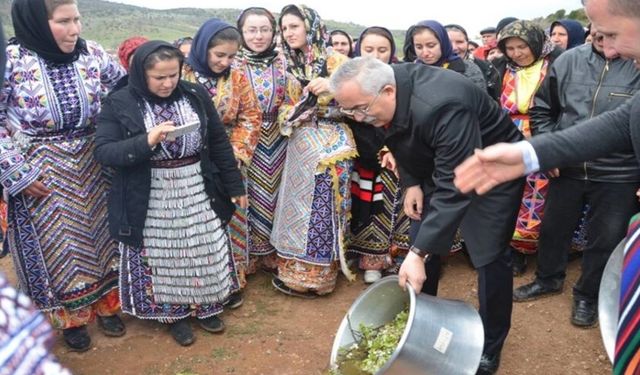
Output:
(128, 40), (184, 103)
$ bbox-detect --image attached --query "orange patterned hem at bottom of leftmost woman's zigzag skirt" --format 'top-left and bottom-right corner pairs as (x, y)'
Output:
(45, 289), (120, 329)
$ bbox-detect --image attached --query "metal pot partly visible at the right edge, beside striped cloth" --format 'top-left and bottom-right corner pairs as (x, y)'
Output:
(598, 239), (627, 363)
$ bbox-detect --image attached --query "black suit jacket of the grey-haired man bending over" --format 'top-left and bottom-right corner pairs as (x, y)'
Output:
(386, 64), (522, 267)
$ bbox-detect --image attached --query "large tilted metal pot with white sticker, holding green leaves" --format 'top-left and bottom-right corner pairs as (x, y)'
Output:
(331, 276), (484, 375)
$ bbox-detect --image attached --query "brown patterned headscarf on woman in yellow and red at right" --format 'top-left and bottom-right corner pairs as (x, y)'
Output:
(498, 20), (555, 70)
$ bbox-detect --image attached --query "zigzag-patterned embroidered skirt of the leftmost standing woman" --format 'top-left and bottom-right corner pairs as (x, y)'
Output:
(5, 130), (118, 311)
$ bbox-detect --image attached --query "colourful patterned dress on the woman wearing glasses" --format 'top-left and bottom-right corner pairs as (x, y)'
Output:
(236, 37), (302, 271)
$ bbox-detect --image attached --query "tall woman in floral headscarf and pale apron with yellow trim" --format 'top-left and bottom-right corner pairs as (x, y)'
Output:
(271, 5), (357, 297)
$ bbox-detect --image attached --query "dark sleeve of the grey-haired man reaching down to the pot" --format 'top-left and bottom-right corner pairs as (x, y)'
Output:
(414, 104), (482, 255)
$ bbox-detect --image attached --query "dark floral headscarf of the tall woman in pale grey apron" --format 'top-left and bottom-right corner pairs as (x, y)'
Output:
(278, 4), (329, 86)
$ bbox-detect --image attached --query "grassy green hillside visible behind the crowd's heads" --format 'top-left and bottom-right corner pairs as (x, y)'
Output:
(0, 0), (587, 55)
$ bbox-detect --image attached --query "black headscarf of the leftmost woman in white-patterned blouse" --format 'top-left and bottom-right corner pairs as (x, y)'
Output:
(11, 0), (87, 64)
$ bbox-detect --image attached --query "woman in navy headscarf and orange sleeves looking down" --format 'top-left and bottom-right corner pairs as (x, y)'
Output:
(183, 18), (262, 308)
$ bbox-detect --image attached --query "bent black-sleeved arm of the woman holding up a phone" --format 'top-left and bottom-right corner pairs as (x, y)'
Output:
(93, 96), (153, 167)
